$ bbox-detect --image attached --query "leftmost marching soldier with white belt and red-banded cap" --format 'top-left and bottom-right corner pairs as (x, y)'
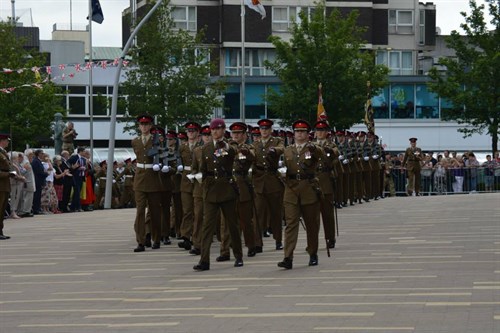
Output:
(132, 115), (161, 252)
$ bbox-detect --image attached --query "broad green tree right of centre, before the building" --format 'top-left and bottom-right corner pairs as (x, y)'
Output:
(267, 0), (388, 129)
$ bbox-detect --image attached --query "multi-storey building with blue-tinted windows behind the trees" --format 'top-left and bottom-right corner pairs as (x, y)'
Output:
(25, 0), (491, 151)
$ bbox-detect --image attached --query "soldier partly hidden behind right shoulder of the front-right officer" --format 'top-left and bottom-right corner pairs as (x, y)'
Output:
(314, 120), (339, 248)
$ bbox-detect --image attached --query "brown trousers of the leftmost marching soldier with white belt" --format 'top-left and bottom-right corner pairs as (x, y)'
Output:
(134, 191), (162, 245)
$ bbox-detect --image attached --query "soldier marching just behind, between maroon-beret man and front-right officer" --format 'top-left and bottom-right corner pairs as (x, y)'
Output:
(252, 119), (285, 253)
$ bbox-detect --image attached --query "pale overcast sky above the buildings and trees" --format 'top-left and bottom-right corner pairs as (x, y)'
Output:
(0, 0), (487, 47)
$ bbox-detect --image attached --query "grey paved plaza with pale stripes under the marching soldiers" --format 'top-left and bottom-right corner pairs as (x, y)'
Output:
(0, 194), (500, 333)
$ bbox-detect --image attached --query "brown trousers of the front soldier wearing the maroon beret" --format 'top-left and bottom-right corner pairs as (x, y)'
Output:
(200, 198), (243, 263)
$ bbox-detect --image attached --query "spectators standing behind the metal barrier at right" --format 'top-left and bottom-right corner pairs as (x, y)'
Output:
(386, 150), (500, 195)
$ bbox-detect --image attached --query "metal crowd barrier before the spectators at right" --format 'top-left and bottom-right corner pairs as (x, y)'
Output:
(384, 167), (500, 196)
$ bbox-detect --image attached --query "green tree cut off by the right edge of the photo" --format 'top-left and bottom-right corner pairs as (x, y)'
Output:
(429, 0), (500, 151)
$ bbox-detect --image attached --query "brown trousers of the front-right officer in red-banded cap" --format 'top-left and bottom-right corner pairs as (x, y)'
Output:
(284, 200), (320, 259)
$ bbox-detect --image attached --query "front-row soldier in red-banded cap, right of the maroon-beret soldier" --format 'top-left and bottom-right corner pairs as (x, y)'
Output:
(278, 120), (323, 269)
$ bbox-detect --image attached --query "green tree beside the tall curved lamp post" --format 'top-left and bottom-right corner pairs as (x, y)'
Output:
(123, 1), (223, 131)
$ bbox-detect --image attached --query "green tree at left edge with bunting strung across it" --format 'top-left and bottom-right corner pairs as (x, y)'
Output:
(0, 22), (64, 150)
